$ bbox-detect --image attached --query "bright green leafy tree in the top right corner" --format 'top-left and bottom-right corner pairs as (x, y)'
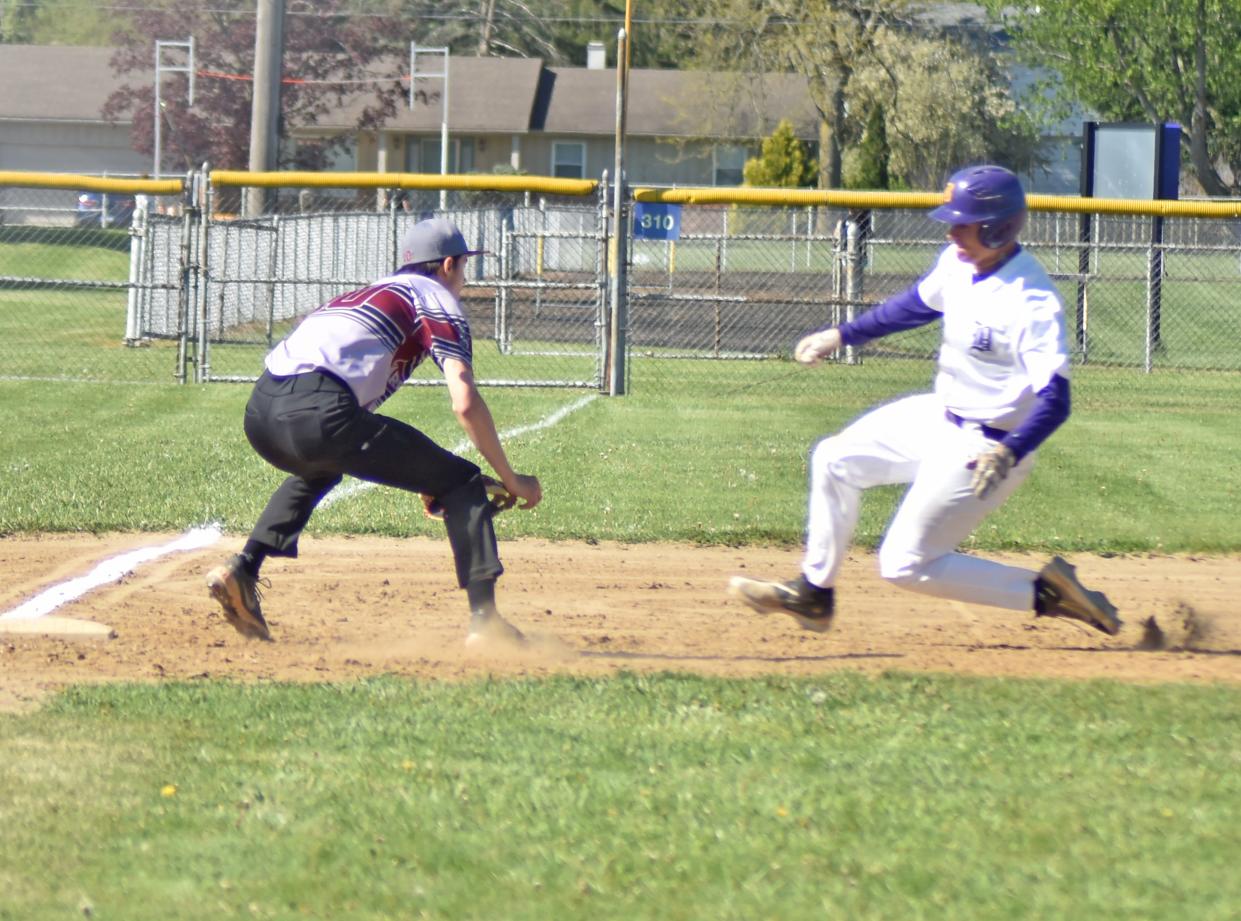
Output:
(988, 0), (1241, 196)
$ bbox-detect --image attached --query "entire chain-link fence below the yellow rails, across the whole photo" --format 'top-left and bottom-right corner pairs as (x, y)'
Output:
(0, 171), (1241, 404)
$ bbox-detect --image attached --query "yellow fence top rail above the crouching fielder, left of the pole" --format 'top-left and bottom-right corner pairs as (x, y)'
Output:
(211, 170), (599, 195)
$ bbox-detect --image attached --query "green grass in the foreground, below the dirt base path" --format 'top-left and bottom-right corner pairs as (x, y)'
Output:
(0, 674), (1241, 921)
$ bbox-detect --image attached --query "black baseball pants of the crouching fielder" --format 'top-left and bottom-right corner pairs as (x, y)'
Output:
(246, 371), (504, 588)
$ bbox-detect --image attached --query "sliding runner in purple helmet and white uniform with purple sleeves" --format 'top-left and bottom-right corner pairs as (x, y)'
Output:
(730, 166), (1121, 634)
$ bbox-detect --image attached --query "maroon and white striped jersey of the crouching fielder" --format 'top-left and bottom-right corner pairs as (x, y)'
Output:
(267, 274), (473, 411)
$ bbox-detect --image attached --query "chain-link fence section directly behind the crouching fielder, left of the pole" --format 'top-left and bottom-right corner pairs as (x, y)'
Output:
(186, 178), (607, 389)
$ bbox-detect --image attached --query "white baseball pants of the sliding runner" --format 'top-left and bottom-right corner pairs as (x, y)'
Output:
(802, 393), (1037, 611)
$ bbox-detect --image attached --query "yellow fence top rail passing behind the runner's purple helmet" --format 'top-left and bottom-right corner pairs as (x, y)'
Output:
(633, 186), (1241, 217)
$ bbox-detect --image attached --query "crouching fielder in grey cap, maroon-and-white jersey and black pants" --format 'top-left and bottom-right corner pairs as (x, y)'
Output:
(207, 218), (542, 644)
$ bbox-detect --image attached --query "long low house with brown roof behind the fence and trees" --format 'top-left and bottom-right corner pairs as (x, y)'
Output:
(0, 45), (818, 194)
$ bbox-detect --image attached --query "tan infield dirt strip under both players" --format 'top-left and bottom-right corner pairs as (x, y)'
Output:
(0, 534), (1241, 709)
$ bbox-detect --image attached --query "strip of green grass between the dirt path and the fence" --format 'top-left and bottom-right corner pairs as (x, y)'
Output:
(0, 361), (1241, 552)
